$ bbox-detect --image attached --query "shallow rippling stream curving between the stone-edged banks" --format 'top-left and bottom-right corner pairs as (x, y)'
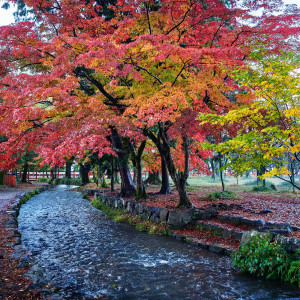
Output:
(18, 186), (300, 299)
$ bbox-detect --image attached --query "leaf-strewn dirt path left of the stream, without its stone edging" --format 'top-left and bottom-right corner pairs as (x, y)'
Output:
(0, 184), (43, 299)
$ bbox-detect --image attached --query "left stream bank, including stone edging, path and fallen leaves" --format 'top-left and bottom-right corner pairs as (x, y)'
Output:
(0, 185), (48, 299)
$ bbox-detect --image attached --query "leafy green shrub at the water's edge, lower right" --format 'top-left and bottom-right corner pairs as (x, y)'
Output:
(232, 233), (300, 286)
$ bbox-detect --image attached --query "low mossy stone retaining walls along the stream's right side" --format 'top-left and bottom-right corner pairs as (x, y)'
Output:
(86, 189), (300, 255)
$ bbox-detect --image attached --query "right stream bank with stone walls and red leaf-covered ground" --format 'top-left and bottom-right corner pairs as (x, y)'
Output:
(85, 184), (300, 255)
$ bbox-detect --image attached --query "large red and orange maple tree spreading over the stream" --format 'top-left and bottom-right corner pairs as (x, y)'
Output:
(0, 0), (299, 207)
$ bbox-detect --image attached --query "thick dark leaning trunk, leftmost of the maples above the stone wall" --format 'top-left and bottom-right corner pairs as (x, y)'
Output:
(111, 127), (136, 197)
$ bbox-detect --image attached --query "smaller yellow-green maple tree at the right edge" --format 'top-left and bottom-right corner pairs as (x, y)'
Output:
(201, 51), (300, 189)
